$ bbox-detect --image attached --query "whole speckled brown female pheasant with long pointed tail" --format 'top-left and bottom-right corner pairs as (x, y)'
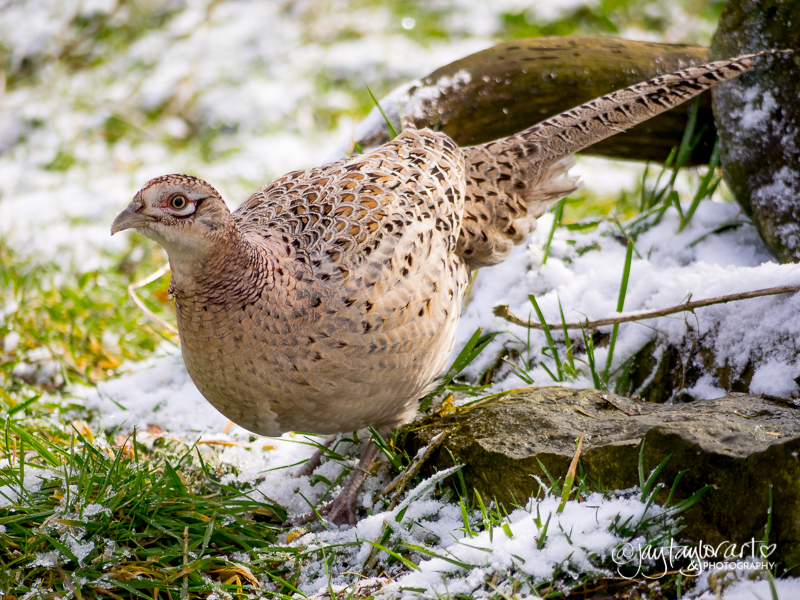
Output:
(111, 54), (776, 524)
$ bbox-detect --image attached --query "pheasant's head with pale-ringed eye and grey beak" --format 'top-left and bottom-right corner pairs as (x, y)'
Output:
(111, 175), (233, 259)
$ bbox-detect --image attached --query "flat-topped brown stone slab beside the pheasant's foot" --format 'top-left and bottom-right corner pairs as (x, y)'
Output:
(405, 387), (800, 574)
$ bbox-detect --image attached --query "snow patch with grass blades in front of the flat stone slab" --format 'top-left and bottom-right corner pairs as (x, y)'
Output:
(292, 490), (660, 598)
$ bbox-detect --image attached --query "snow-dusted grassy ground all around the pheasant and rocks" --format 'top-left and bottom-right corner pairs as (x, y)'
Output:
(0, 0), (800, 600)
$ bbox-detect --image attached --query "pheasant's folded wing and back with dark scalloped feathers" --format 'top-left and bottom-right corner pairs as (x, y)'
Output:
(233, 129), (464, 279)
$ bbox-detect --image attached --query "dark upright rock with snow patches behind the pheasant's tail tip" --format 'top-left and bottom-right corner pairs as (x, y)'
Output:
(710, 0), (800, 263)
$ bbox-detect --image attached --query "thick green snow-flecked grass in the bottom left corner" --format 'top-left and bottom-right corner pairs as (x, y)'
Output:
(0, 409), (291, 598)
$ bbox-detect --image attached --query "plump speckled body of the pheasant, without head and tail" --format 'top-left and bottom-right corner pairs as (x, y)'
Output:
(172, 131), (467, 435)
